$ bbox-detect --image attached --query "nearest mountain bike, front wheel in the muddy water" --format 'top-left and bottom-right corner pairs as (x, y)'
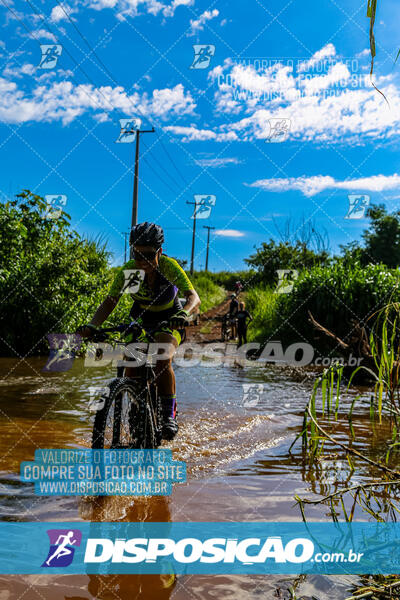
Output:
(86, 321), (186, 449)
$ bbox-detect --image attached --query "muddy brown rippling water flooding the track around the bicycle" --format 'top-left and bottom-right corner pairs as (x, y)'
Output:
(0, 358), (394, 600)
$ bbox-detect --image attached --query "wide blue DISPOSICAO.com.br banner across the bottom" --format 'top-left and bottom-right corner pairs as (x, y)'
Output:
(0, 522), (400, 575)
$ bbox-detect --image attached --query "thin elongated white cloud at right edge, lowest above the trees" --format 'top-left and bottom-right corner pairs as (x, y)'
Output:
(246, 173), (400, 197)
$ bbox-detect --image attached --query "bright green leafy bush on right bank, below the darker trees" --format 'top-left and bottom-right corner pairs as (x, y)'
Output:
(242, 260), (400, 349)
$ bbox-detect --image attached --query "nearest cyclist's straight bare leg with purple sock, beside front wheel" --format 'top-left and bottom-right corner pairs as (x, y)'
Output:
(154, 331), (180, 439)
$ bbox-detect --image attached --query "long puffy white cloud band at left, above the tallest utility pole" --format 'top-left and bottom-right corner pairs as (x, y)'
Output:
(0, 78), (196, 124)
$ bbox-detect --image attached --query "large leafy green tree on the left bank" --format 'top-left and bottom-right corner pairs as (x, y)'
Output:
(0, 190), (111, 356)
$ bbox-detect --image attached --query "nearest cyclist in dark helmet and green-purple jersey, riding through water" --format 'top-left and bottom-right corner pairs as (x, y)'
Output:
(79, 222), (200, 440)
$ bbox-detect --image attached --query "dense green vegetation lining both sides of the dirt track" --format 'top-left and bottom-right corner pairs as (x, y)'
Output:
(0, 191), (400, 356)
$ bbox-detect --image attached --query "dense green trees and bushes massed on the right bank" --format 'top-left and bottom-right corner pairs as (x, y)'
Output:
(242, 206), (400, 345)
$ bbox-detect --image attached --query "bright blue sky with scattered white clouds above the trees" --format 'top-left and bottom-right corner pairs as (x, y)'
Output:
(0, 0), (400, 270)
